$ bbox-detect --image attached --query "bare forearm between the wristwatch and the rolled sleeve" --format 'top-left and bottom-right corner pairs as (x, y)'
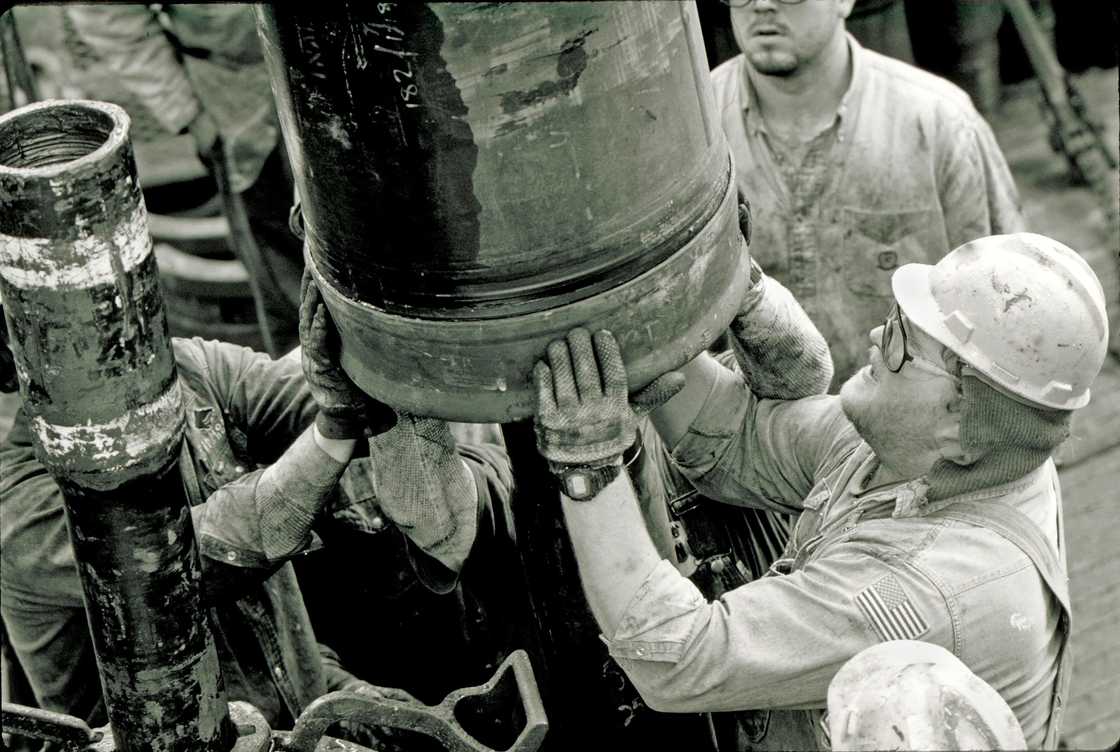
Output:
(561, 472), (660, 637)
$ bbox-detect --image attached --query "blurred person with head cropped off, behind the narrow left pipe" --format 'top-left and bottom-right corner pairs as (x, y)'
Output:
(64, 3), (302, 358)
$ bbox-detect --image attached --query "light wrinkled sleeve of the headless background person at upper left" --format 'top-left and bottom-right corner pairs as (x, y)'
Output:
(65, 3), (202, 133)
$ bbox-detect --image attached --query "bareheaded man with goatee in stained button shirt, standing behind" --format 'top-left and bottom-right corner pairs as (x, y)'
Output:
(711, 0), (1024, 388)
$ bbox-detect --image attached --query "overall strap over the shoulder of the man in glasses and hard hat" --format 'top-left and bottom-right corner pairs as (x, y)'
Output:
(932, 501), (1073, 750)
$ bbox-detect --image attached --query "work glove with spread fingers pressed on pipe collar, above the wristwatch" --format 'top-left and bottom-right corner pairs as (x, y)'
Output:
(533, 328), (684, 474)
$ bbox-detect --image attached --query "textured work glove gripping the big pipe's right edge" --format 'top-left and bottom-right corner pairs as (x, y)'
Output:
(729, 199), (832, 399)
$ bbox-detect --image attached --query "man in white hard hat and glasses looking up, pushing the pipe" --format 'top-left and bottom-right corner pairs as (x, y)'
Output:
(534, 233), (1108, 749)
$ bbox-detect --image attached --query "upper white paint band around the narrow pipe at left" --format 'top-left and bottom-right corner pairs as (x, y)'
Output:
(0, 203), (151, 290)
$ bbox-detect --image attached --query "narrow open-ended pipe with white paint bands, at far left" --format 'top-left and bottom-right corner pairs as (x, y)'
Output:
(0, 101), (234, 752)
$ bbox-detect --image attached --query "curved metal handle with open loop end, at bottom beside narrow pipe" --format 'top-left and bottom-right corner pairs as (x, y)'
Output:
(274, 650), (548, 752)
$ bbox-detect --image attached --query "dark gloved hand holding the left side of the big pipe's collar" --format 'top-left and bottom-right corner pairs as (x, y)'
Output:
(299, 269), (367, 438)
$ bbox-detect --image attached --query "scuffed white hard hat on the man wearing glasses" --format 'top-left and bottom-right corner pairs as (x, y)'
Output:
(890, 232), (1109, 410)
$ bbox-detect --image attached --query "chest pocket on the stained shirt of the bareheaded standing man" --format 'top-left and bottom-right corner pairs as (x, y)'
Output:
(841, 208), (951, 298)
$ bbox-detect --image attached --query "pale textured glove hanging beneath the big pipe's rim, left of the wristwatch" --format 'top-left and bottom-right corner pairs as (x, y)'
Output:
(370, 412), (478, 572)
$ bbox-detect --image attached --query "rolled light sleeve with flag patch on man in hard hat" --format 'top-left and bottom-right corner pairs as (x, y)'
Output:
(607, 545), (952, 713)
